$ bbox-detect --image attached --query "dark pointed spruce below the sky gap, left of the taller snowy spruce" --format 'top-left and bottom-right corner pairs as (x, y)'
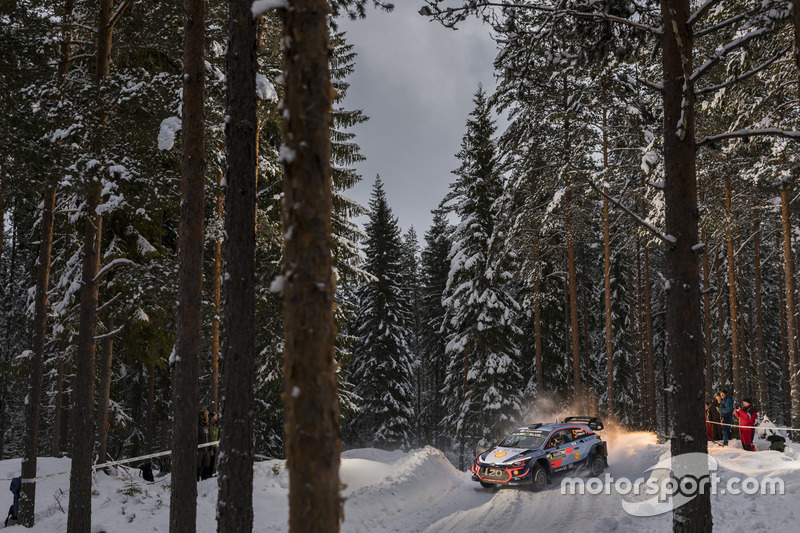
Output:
(349, 177), (414, 449)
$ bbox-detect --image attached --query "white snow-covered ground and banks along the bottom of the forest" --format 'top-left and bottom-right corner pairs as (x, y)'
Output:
(0, 431), (800, 533)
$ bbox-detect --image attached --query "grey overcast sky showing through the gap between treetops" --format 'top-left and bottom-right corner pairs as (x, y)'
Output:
(339, 0), (495, 239)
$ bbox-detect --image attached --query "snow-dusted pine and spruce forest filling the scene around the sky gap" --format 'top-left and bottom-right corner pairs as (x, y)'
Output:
(0, 0), (800, 531)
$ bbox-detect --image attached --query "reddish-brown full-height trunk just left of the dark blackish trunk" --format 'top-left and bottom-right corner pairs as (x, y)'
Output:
(169, 0), (205, 533)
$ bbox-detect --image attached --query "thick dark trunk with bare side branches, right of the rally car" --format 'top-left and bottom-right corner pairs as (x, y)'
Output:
(661, 0), (712, 533)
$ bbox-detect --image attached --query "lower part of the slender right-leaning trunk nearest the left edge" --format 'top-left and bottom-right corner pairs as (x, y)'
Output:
(19, 187), (56, 527)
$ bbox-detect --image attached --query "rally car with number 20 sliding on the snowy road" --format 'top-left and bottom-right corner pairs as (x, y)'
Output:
(471, 416), (608, 491)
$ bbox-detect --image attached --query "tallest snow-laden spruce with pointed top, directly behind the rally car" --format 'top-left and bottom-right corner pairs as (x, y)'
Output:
(443, 88), (523, 467)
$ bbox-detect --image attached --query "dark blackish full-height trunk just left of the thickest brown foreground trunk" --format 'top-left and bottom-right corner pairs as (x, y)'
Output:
(217, 0), (256, 532)
